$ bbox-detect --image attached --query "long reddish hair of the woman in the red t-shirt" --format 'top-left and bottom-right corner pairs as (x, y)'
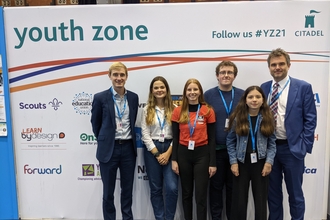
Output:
(179, 78), (211, 123)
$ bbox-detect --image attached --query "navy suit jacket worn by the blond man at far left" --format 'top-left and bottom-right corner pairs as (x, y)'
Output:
(91, 89), (139, 163)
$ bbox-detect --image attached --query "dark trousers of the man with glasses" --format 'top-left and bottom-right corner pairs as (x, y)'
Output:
(209, 149), (233, 220)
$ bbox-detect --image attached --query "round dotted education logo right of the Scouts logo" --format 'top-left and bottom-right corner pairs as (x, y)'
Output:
(72, 92), (93, 115)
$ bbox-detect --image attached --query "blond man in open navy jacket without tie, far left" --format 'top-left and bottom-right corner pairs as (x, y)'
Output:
(91, 62), (139, 220)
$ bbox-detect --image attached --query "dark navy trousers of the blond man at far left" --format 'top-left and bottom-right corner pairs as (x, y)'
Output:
(100, 142), (136, 220)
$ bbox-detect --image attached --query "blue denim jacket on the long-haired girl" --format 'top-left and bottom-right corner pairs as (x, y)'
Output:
(227, 115), (276, 165)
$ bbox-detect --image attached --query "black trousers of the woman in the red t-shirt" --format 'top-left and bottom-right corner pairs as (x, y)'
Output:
(178, 145), (210, 220)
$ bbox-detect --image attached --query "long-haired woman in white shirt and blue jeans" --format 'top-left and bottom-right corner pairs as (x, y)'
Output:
(141, 76), (178, 220)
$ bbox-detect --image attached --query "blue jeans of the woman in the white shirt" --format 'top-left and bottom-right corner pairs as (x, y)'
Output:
(144, 140), (178, 220)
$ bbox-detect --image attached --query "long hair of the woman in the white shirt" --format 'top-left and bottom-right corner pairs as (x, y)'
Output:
(146, 76), (174, 126)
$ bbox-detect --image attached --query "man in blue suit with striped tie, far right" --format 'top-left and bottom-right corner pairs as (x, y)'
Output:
(261, 48), (316, 220)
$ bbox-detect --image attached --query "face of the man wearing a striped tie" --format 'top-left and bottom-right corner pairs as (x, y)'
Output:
(269, 55), (290, 82)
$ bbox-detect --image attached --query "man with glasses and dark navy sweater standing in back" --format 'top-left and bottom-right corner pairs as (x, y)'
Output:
(204, 60), (244, 220)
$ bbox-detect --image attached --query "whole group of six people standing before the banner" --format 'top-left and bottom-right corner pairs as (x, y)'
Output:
(91, 48), (316, 220)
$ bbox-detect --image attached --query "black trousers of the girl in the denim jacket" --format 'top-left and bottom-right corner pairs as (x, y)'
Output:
(231, 155), (269, 220)
